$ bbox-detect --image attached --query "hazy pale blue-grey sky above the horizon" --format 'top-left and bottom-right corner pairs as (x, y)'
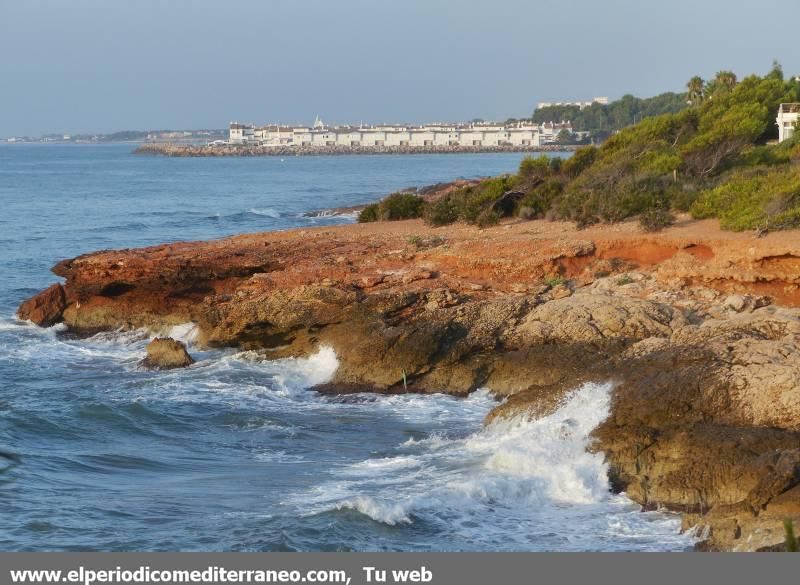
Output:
(0, 0), (800, 137)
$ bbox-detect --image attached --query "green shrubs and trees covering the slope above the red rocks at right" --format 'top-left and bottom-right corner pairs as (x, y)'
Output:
(362, 64), (800, 231)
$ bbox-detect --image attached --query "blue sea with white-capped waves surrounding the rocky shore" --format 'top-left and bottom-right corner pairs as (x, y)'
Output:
(0, 145), (691, 551)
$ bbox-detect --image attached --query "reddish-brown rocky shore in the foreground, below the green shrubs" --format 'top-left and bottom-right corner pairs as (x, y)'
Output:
(19, 212), (800, 550)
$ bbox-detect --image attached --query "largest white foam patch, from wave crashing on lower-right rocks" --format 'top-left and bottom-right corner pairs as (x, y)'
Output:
(293, 384), (691, 550)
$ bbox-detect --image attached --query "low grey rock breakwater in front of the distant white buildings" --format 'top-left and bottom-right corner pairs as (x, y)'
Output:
(133, 143), (577, 157)
